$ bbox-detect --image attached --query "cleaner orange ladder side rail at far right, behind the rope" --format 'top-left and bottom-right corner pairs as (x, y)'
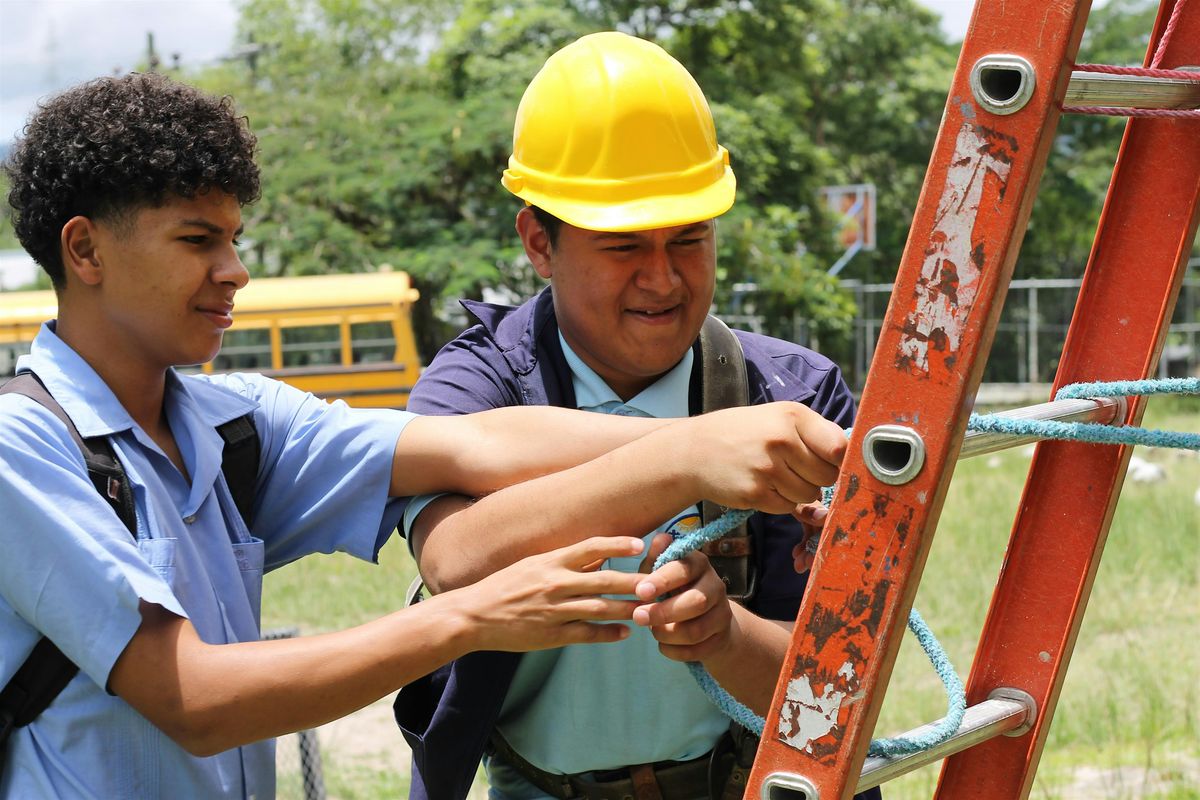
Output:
(936, 0), (1200, 800)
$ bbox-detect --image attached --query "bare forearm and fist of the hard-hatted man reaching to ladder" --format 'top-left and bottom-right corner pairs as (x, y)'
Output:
(413, 403), (846, 591)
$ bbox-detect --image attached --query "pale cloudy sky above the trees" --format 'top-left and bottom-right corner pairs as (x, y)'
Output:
(0, 0), (974, 146)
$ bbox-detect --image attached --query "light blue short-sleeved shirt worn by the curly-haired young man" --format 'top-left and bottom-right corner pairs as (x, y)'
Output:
(0, 325), (413, 800)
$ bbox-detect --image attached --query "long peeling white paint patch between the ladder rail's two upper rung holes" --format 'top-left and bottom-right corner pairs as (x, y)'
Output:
(900, 121), (1009, 374)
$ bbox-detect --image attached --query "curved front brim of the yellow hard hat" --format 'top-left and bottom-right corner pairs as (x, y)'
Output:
(500, 166), (737, 233)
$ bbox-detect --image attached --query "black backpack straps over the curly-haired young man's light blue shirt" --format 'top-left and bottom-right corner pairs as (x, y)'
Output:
(0, 372), (262, 753)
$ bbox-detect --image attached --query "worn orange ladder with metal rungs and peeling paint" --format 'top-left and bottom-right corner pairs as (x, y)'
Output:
(745, 0), (1200, 800)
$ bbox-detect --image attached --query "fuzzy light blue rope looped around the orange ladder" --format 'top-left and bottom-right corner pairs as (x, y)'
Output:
(654, 378), (1200, 757)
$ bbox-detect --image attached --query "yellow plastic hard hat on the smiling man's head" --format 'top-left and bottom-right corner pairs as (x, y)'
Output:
(500, 31), (736, 231)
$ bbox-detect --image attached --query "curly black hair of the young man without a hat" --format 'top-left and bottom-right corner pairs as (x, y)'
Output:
(4, 73), (259, 289)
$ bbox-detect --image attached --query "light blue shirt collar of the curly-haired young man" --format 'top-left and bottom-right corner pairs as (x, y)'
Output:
(17, 320), (257, 439)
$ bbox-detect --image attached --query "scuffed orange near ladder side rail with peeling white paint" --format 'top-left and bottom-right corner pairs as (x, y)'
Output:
(746, 0), (1090, 800)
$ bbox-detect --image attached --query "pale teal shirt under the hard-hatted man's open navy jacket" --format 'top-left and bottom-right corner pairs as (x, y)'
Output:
(488, 335), (730, 800)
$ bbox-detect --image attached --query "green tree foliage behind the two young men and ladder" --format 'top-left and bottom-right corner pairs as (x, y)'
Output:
(184, 0), (1148, 359)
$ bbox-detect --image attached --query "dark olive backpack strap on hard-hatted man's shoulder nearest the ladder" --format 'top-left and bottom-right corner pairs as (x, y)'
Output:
(700, 315), (757, 603)
